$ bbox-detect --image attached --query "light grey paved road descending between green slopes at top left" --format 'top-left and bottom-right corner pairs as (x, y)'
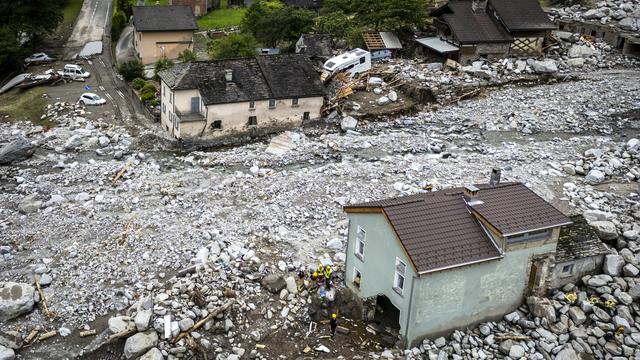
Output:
(67, 0), (111, 47)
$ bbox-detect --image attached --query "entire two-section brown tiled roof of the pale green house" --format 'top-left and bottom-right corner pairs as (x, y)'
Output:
(344, 183), (571, 274)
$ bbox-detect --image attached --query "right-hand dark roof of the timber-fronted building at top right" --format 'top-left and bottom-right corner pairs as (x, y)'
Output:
(489, 0), (556, 31)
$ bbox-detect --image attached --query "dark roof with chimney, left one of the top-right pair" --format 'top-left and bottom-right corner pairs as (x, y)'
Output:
(432, 1), (513, 44)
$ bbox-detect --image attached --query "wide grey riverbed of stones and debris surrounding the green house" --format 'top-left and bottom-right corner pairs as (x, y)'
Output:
(0, 67), (640, 359)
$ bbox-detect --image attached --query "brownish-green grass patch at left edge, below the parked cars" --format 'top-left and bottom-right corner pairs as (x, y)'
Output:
(0, 86), (47, 124)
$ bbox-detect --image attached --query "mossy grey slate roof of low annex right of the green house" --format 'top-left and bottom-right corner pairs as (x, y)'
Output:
(556, 215), (609, 263)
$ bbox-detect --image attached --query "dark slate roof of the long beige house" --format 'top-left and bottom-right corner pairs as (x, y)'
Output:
(158, 55), (324, 105)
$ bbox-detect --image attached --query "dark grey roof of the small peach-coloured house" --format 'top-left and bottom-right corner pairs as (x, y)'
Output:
(133, 5), (198, 32)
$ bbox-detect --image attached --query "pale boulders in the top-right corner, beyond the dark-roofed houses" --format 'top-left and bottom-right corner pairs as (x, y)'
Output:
(550, 0), (640, 32)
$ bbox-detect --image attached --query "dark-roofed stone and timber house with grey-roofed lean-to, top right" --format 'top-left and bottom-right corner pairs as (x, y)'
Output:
(416, 0), (556, 63)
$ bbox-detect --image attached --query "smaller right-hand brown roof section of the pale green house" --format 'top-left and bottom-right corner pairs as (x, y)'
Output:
(473, 183), (571, 235)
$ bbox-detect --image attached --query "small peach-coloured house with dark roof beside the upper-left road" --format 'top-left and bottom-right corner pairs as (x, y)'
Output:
(133, 5), (198, 65)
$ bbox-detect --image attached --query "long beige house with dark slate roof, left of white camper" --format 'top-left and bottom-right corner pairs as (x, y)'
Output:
(159, 55), (324, 140)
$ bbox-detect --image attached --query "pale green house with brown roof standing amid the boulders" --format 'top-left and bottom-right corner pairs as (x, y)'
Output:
(344, 181), (571, 345)
